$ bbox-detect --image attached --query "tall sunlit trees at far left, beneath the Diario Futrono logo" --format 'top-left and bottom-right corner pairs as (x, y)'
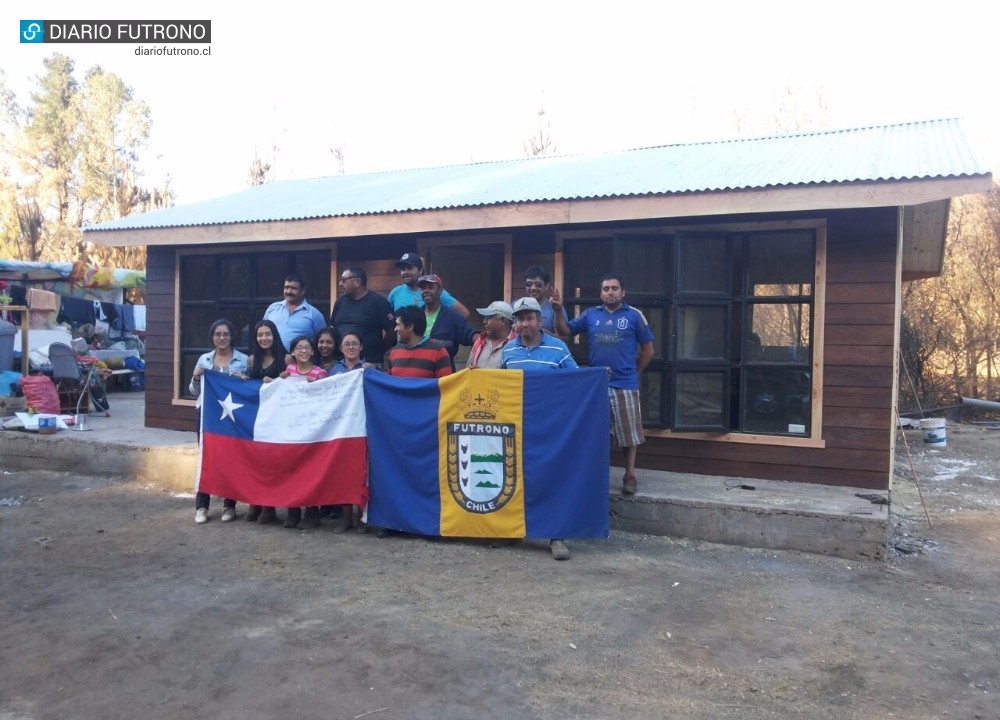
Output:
(0, 53), (172, 268)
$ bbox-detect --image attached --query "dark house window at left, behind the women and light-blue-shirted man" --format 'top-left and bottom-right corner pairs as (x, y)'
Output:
(178, 250), (331, 398)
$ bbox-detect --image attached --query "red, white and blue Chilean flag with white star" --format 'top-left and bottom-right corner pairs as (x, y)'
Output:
(196, 371), (368, 507)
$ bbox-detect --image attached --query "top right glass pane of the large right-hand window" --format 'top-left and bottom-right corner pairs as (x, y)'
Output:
(747, 232), (815, 297)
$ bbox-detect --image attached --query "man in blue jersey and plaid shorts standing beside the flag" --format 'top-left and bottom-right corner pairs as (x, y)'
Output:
(551, 273), (653, 495)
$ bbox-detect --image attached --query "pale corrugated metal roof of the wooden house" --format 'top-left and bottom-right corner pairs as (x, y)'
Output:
(84, 119), (990, 231)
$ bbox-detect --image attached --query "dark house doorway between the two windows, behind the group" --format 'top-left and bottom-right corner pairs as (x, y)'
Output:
(424, 242), (507, 370)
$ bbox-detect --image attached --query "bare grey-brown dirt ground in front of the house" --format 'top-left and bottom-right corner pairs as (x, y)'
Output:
(0, 425), (1000, 720)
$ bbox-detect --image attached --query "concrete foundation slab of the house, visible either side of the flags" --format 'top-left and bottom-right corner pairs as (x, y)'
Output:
(0, 393), (889, 560)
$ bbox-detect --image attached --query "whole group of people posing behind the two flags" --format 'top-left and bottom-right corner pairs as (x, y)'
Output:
(189, 253), (653, 560)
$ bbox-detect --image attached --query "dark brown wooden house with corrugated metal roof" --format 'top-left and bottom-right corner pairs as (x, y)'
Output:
(84, 120), (992, 489)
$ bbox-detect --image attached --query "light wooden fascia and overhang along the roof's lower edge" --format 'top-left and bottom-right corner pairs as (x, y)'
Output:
(84, 173), (992, 252)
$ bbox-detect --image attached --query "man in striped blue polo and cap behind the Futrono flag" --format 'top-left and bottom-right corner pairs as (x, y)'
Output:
(500, 297), (578, 560)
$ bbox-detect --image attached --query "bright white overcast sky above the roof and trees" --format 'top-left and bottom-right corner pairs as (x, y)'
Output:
(0, 0), (1000, 205)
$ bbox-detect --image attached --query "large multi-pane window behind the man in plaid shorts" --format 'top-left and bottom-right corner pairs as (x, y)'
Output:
(564, 230), (816, 437)
